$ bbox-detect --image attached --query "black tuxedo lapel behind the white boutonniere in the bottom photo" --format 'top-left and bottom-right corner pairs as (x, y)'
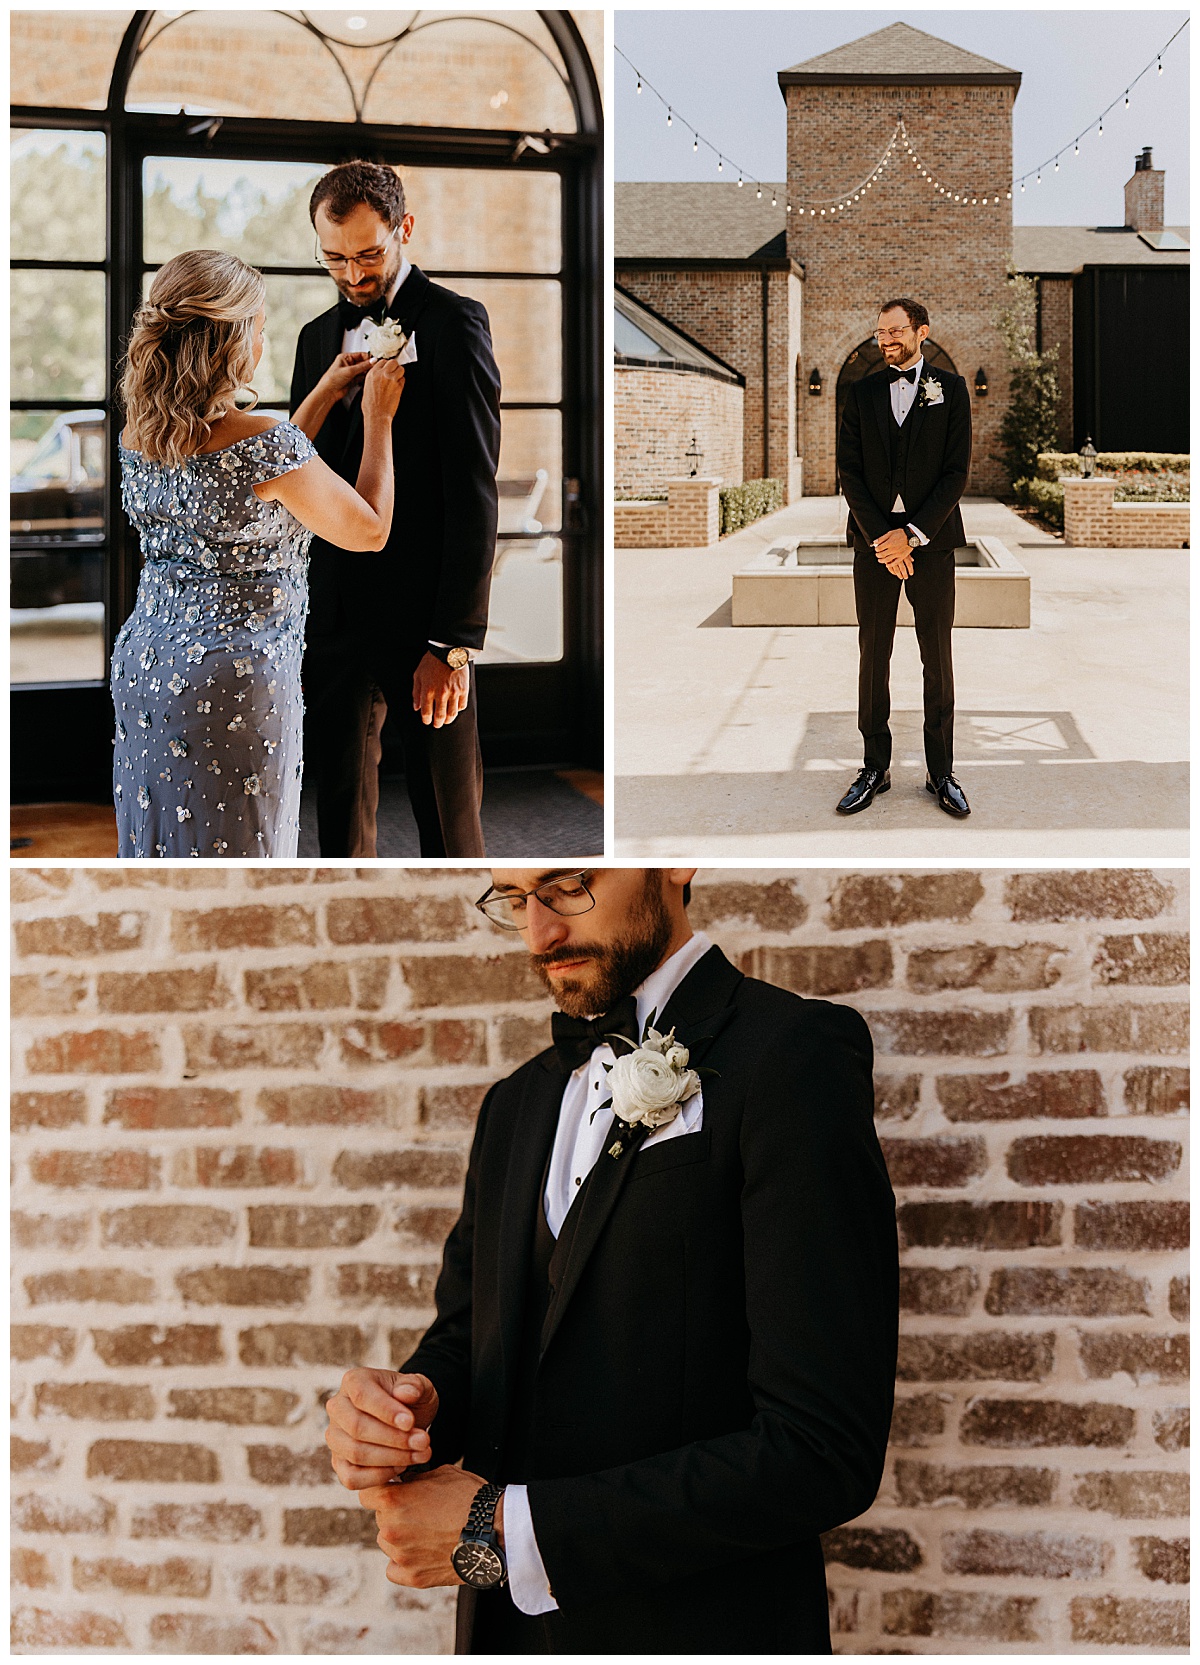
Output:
(541, 947), (742, 1354)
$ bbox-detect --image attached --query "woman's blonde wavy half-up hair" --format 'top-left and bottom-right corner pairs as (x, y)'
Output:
(121, 248), (266, 468)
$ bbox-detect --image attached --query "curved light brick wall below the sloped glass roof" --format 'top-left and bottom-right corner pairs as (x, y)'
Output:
(612, 365), (746, 495)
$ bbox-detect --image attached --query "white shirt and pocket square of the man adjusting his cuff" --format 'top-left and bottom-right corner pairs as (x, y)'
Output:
(504, 931), (712, 1613)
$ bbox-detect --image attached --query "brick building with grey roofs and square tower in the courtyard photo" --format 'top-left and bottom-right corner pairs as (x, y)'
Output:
(616, 23), (1188, 501)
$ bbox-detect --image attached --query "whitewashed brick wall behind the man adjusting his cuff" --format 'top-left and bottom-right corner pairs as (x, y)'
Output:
(12, 867), (1188, 1653)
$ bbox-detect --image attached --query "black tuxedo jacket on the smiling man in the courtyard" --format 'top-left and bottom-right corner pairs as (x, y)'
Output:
(837, 366), (970, 554)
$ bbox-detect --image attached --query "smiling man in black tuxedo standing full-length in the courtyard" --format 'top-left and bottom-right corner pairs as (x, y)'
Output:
(837, 298), (970, 818)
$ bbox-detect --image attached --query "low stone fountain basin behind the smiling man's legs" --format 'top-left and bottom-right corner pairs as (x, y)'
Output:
(734, 538), (1029, 629)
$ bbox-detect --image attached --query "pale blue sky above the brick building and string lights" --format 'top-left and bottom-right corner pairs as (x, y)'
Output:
(614, 10), (1192, 225)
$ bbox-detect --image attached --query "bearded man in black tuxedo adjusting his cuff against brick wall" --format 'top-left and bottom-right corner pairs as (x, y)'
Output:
(326, 867), (899, 1653)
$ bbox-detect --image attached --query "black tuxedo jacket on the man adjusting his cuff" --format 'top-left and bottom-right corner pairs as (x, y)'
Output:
(404, 949), (899, 1653)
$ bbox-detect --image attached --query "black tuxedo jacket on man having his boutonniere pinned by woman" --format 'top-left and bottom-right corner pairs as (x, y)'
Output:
(291, 266), (499, 663)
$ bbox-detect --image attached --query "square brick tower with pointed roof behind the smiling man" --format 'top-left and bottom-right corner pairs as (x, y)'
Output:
(779, 23), (1020, 496)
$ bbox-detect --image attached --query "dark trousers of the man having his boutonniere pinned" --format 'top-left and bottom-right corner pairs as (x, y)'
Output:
(305, 648), (484, 857)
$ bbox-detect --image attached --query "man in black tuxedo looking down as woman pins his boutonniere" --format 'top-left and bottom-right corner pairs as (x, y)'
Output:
(291, 162), (499, 856)
